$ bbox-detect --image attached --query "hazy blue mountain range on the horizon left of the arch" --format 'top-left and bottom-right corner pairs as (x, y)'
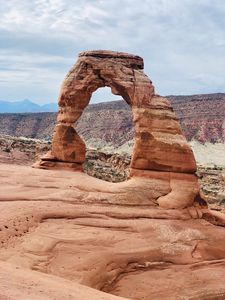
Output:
(0, 99), (58, 113)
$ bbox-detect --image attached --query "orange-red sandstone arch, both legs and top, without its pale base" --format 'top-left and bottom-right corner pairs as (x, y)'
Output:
(36, 50), (196, 175)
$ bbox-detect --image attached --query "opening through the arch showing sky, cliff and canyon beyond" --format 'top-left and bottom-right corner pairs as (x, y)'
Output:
(75, 87), (134, 182)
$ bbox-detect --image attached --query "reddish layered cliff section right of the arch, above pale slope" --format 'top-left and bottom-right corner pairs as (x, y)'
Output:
(168, 93), (225, 143)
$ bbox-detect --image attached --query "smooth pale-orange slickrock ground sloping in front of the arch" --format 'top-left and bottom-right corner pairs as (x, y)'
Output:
(0, 164), (225, 300)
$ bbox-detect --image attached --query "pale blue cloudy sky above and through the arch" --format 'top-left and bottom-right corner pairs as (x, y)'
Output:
(0, 0), (225, 103)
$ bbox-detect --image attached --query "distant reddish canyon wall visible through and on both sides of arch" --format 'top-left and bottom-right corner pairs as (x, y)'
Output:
(0, 94), (225, 148)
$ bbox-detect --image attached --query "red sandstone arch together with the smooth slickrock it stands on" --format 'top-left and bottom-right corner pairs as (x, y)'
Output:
(0, 51), (225, 300)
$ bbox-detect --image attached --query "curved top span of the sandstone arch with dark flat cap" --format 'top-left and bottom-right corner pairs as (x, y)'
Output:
(59, 50), (154, 110)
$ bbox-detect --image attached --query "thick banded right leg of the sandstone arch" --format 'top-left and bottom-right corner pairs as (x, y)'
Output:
(131, 96), (196, 173)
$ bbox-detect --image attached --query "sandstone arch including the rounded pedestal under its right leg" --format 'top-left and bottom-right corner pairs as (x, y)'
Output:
(35, 50), (199, 209)
